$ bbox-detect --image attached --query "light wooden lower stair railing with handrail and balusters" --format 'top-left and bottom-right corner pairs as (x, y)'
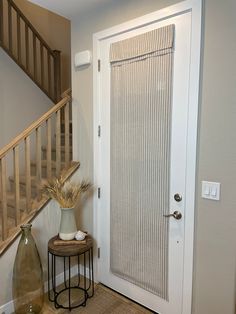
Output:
(0, 89), (71, 241)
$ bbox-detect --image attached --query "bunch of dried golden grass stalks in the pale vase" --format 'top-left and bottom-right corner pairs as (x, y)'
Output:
(42, 177), (91, 208)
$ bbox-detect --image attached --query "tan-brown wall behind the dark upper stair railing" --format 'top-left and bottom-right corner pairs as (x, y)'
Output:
(14, 0), (71, 91)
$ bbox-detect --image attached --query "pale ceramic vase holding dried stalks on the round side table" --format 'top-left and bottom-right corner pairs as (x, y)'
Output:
(59, 208), (77, 240)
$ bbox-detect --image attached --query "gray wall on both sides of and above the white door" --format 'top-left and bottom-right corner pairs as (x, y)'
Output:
(72, 0), (236, 314)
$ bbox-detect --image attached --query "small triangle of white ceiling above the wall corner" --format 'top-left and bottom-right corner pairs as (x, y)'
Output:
(30, 0), (112, 19)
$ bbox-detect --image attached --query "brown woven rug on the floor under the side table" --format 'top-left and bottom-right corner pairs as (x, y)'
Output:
(43, 284), (153, 314)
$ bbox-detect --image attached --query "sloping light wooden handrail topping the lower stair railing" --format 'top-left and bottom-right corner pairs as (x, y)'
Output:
(0, 96), (70, 159)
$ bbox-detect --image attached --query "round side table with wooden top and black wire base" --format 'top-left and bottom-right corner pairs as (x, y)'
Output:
(48, 235), (94, 311)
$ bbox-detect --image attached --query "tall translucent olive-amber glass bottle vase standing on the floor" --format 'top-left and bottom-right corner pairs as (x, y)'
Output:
(12, 224), (44, 314)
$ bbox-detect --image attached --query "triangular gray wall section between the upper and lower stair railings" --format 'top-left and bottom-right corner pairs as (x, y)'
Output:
(0, 48), (52, 149)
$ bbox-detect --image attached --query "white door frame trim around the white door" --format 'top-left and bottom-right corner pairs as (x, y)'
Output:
(93, 0), (202, 314)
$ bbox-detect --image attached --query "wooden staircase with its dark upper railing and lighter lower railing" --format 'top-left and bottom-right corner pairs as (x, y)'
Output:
(0, 0), (79, 255)
